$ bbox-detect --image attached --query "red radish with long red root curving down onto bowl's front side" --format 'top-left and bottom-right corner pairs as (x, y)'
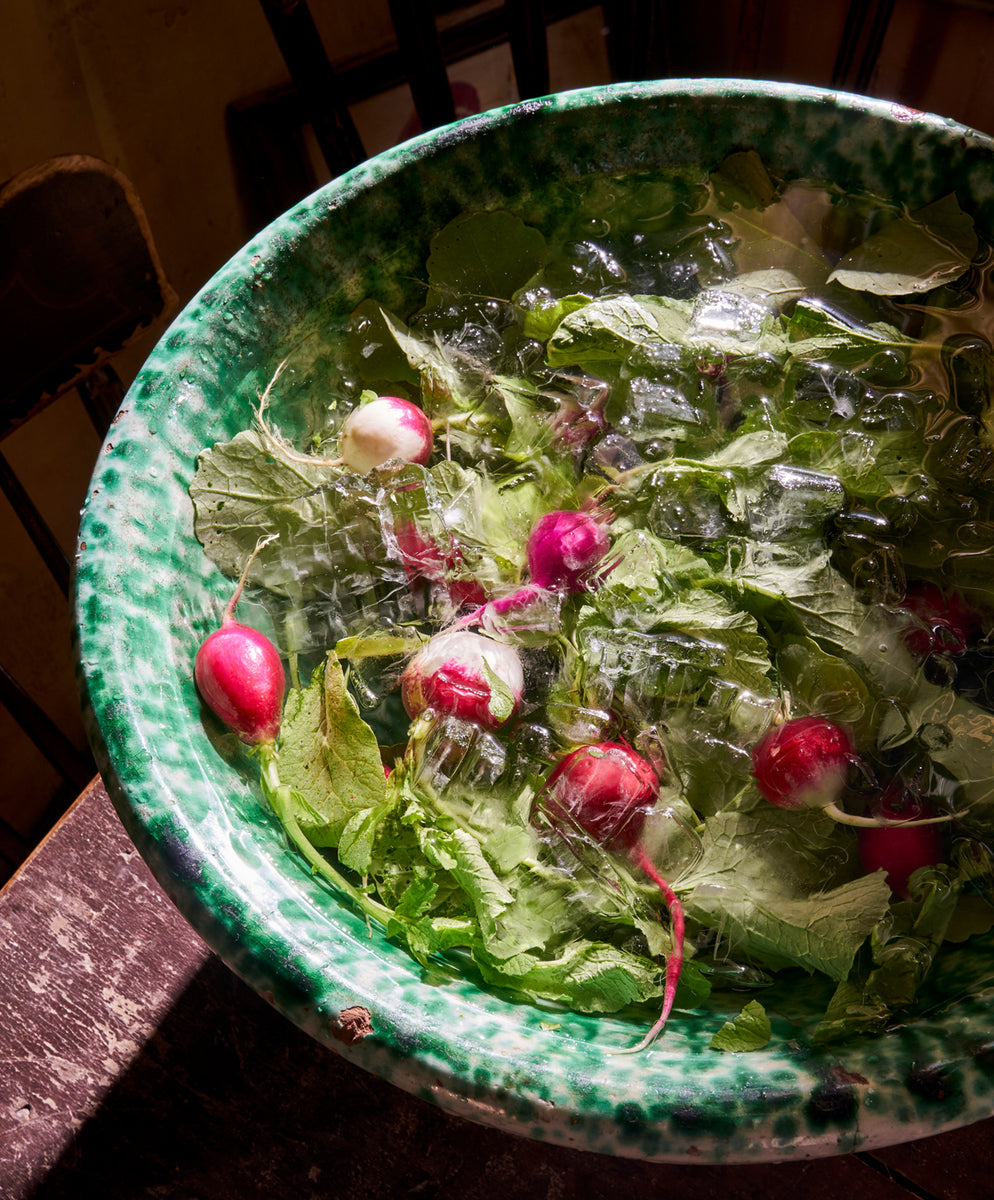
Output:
(537, 742), (684, 1054)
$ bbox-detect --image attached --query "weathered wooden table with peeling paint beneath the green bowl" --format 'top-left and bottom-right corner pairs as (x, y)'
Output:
(0, 780), (994, 1200)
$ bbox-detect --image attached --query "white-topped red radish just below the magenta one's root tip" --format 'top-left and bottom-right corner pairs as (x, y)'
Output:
(401, 629), (525, 730)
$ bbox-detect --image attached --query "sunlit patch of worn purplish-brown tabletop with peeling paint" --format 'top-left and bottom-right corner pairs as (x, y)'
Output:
(0, 782), (210, 1195)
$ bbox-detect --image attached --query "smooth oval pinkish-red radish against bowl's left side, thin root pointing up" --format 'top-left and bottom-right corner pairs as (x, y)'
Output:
(193, 542), (286, 746)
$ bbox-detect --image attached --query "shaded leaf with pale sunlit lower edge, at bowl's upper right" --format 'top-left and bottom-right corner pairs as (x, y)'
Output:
(830, 194), (977, 296)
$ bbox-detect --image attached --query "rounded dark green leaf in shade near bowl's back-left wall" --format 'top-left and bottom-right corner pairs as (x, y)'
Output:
(427, 211), (545, 306)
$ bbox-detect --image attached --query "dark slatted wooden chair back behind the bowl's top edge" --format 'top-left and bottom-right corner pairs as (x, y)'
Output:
(228, 0), (894, 226)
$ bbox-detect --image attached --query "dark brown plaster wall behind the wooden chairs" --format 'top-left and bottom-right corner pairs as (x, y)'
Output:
(0, 0), (994, 854)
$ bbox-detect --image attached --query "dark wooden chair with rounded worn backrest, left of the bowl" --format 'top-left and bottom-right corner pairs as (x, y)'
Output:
(0, 156), (175, 865)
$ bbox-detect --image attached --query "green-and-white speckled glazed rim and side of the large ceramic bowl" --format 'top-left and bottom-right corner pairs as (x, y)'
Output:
(77, 80), (994, 1163)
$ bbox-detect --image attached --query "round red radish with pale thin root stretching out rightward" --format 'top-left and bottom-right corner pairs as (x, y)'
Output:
(753, 716), (952, 829)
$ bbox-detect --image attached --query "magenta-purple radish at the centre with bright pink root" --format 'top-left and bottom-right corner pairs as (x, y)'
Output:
(460, 509), (610, 625)
